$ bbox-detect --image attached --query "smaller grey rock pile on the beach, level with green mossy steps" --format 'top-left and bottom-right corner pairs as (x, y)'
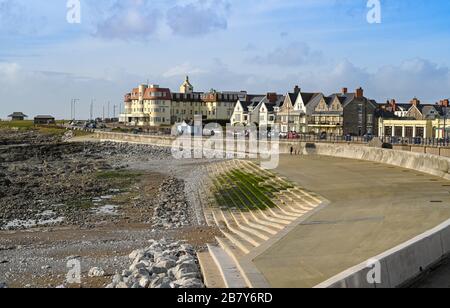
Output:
(153, 178), (189, 229)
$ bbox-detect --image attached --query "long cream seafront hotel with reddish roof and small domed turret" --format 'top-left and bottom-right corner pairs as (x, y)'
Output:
(121, 77), (247, 128)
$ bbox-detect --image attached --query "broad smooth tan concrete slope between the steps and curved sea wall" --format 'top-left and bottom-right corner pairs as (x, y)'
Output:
(254, 156), (450, 287)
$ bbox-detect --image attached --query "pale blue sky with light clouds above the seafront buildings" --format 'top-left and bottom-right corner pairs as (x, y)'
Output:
(0, 0), (450, 119)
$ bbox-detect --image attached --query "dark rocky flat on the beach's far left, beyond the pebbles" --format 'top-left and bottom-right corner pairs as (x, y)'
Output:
(0, 143), (174, 230)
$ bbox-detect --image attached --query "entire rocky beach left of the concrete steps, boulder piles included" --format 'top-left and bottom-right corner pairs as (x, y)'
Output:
(0, 133), (217, 288)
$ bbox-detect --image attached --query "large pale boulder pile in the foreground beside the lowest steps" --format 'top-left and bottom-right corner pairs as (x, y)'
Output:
(107, 239), (204, 289)
